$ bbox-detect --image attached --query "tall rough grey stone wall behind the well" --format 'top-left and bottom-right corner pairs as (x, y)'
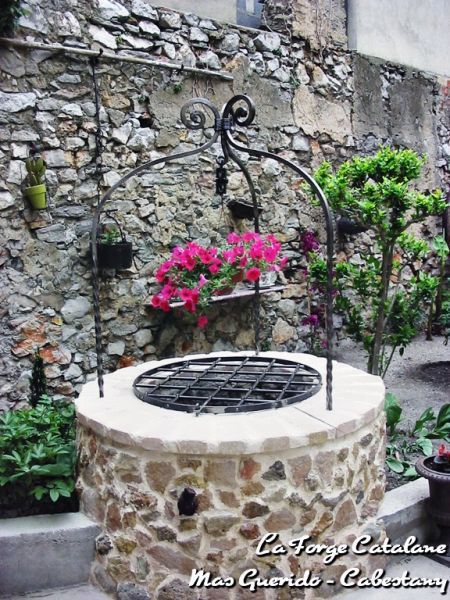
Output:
(0, 0), (449, 409)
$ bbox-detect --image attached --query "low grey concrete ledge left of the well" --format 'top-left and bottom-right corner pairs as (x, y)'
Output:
(0, 513), (99, 598)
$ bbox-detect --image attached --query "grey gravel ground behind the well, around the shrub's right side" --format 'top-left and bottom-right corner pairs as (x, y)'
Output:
(335, 336), (450, 425)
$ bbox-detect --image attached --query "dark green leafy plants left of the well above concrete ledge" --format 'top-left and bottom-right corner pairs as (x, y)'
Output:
(0, 396), (76, 506)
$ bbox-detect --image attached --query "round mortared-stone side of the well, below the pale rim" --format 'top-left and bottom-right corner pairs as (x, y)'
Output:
(78, 415), (385, 600)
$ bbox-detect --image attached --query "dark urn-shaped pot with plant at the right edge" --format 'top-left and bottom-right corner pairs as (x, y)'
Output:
(416, 444), (450, 566)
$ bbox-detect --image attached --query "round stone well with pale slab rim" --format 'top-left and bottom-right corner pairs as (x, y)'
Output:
(76, 352), (385, 600)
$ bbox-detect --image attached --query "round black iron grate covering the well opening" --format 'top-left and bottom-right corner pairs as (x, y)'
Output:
(133, 356), (322, 414)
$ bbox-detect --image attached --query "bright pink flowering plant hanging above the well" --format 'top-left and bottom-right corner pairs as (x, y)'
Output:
(151, 231), (287, 328)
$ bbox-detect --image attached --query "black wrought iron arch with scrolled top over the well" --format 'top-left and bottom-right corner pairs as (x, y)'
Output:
(91, 94), (334, 410)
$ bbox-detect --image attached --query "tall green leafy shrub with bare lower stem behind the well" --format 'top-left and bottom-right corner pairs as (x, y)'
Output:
(313, 148), (446, 375)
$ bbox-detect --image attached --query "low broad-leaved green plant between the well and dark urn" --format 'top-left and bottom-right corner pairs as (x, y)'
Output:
(384, 393), (450, 479)
